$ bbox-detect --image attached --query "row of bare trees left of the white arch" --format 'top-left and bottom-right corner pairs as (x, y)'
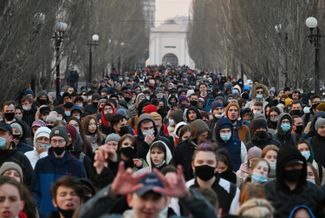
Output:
(0, 0), (149, 102)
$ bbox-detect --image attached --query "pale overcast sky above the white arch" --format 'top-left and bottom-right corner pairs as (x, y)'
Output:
(156, 0), (191, 26)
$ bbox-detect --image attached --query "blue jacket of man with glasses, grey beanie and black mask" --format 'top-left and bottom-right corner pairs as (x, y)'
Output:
(32, 151), (86, 218)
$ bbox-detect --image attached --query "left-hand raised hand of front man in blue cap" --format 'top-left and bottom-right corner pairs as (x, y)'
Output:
(112, 161), (148, 195)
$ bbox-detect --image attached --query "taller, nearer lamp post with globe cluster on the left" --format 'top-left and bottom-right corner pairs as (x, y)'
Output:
(53, 21), (68, 98)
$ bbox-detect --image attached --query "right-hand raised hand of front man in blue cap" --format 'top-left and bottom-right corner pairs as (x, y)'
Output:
(154, 165), (188, 198)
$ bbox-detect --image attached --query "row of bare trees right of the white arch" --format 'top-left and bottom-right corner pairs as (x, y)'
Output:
(188, 0), (325, 88)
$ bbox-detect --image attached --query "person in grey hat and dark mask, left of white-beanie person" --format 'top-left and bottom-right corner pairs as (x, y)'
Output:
(10, 122), (33, 153)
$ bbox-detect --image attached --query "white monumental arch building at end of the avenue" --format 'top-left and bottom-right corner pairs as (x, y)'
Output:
(146, 20), (195, 68)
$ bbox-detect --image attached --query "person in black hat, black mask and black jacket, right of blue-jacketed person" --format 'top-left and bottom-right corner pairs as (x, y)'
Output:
(246, 117), (280, 149)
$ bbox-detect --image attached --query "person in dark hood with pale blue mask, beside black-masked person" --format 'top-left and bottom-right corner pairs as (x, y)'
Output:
(274, 113), (296, 149)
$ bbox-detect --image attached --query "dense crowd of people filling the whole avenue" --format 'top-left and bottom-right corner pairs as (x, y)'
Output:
(0, 66), (325, 218)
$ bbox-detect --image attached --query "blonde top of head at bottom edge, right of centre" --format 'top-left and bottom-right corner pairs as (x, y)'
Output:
(238, 198), (274, 218)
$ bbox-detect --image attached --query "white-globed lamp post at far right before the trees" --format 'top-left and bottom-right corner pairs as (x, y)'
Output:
(306, 17), (321, 95)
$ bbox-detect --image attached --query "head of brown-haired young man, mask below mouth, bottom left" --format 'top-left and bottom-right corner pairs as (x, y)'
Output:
(49, 176), (84, 218)
